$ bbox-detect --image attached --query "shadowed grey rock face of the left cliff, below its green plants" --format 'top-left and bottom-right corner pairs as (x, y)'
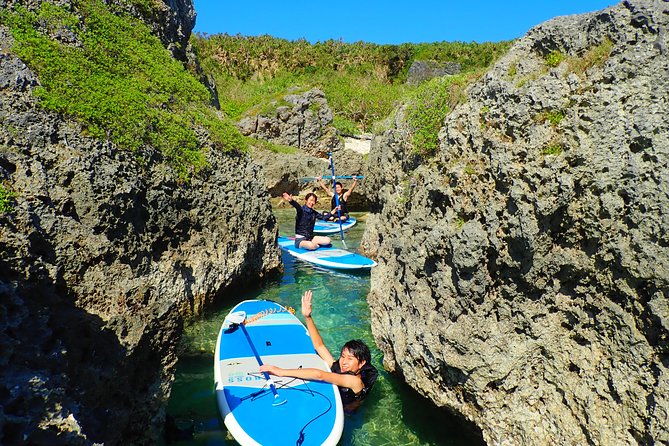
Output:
(0, 2), (280, 445)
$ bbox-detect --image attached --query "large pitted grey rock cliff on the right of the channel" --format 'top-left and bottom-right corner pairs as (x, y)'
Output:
(363, 0), (669, 445)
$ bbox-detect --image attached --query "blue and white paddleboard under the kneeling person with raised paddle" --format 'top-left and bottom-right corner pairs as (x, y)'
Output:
(279, 237), (376, 270)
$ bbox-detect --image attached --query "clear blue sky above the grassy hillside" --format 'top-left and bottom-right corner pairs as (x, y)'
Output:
(194, 0), (617, 44)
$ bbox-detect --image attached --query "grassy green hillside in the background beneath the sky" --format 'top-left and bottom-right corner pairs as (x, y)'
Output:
(191, 34), (511, 151)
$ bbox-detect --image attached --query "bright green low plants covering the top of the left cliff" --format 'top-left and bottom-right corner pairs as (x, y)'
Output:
(0, 0), (245, 180)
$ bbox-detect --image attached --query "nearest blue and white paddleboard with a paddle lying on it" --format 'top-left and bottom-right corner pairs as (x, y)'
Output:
(214, 300), (344, 446)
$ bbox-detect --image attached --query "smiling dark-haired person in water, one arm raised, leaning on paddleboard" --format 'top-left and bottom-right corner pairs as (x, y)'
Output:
(260, 290), (378, 411)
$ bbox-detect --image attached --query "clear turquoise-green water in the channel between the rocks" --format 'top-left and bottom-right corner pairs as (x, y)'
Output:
(167, 209), (481, 446)
